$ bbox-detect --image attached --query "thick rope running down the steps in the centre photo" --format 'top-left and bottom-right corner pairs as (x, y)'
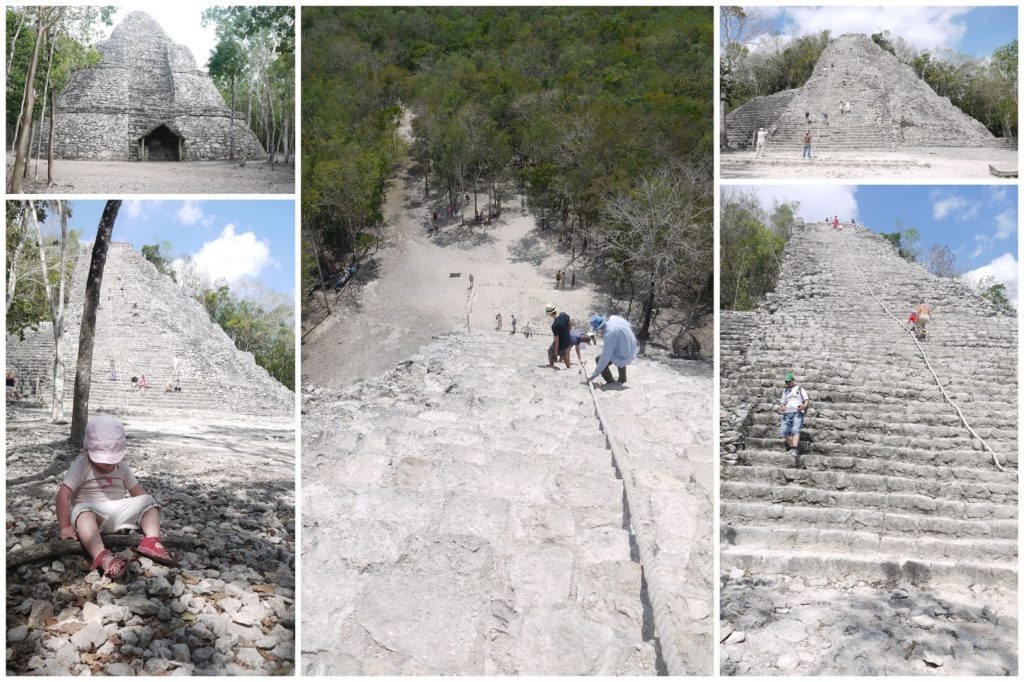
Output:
(581, 360), (686, 676)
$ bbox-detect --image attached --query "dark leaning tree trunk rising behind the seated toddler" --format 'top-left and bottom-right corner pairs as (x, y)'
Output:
(71, 200), (121, 447)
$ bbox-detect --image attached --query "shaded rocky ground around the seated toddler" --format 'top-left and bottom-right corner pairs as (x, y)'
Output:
(6, 410), (295, 675)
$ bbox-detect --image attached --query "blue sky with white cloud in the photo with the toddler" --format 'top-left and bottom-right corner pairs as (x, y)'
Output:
(62, 200), (295, 299)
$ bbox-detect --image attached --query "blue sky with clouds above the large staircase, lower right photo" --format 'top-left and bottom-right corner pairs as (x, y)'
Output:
(749, 184), (1019, 300)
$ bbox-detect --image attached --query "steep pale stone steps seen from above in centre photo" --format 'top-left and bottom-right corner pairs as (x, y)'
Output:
(302, 332), (713, 675)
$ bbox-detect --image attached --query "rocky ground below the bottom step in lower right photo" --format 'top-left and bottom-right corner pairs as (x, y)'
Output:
(719, 567), (1018, 676)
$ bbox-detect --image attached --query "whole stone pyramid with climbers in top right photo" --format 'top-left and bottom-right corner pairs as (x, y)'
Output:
(726, 34), (1012, 151)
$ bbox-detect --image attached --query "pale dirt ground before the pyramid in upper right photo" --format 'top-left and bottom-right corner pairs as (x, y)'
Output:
(719, 145), (1017, 182)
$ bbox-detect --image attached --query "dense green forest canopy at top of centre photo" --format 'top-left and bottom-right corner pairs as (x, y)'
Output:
(302, 7), (714, 337)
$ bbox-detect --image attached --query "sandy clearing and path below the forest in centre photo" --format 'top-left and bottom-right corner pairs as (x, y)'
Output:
(302, 165), (597, 387)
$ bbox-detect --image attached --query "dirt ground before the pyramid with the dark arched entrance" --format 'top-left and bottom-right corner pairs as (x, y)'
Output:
(6, 157), (295, 195)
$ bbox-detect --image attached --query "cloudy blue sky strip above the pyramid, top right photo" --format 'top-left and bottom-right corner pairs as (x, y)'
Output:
(743, 5), (1018, 57)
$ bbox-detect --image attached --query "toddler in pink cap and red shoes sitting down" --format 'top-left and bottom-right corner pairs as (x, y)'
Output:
(56, 415), (175, 580)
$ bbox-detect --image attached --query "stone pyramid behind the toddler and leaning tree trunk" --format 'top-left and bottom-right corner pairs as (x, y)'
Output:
(7, 243), (295, 419)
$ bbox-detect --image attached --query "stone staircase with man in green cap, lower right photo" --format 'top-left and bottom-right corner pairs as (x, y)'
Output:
(720, 223), (1018, 584)
